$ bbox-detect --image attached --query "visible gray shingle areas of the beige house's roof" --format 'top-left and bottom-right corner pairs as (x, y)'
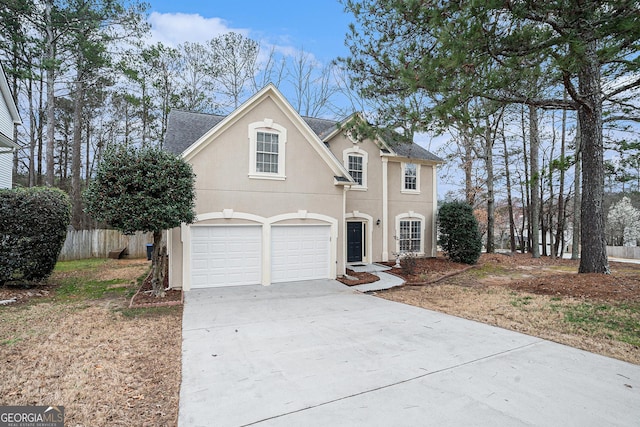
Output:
(164, 110), (443, 162)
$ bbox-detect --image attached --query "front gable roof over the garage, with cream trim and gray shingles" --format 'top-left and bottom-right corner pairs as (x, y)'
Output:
(164, 84), (353, 183)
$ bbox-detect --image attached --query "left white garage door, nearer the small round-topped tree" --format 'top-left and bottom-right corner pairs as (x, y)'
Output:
(191, 226), (262, 288)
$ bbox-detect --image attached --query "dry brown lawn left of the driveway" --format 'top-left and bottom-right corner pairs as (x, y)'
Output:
(0, 260), (182, 426)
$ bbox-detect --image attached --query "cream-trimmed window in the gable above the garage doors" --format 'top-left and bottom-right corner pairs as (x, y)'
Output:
(249, 119), (287, 180)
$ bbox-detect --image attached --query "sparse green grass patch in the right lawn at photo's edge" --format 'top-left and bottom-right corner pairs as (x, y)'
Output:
(564, 302), (640, 346)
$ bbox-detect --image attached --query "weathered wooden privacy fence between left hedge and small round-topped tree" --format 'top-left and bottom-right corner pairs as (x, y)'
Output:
(58, 230), (153, 261)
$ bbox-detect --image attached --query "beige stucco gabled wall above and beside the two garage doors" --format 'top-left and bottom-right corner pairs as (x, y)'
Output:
(170, 93), (344, 287)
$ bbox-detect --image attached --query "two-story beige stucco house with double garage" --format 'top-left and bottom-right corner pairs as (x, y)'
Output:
(165, 85), (442, 290)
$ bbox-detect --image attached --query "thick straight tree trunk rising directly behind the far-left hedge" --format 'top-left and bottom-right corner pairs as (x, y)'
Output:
(44, 0), (56, 187)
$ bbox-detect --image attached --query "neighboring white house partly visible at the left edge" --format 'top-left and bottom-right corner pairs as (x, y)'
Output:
(0, 64), (22, 188)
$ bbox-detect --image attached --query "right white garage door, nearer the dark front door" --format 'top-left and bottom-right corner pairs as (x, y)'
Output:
(271, 225), (331, 283)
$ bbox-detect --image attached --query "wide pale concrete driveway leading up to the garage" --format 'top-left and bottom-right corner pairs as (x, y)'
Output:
(179, 280), (640, 427)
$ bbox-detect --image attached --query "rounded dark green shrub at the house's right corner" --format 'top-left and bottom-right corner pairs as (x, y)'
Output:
(438, 201), (482, 264)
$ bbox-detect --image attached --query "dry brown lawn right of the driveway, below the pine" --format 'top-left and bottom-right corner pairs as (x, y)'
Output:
(377, 254), (640, 364)
